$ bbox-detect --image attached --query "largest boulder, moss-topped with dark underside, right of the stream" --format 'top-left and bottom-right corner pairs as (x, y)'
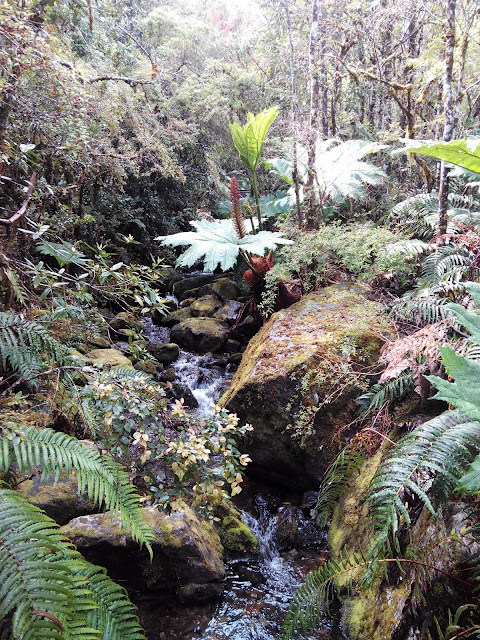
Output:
(221, 283), (393, 489)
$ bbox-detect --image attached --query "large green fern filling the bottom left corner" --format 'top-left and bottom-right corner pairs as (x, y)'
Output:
(0, 489), (144, 640)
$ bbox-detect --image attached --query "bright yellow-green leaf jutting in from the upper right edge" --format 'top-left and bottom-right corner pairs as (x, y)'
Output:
(402, 138), (480, 174)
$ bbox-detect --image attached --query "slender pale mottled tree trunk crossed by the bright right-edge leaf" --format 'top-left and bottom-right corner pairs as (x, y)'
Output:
(438, 0), (456, 235)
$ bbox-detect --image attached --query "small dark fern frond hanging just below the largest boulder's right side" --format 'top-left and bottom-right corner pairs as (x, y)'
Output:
(315, 446), (365, 527)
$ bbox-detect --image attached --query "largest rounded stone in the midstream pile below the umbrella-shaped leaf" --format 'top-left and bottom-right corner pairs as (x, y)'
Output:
(170, 318), (228, 353)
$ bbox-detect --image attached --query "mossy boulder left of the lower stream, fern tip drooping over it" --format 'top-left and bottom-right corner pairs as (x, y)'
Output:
(62, 505), (225, 592)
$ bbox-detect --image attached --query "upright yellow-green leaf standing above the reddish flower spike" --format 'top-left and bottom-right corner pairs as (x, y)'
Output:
(229, 106), (279, 172)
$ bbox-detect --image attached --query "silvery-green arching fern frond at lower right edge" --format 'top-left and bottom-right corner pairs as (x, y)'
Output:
(367, 411), (480, 552)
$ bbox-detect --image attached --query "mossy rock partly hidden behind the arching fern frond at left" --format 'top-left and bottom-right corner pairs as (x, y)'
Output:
(16, 473), (98, 525)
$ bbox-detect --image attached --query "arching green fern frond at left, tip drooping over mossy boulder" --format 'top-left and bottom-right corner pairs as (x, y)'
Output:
(0, 425), (155, 554)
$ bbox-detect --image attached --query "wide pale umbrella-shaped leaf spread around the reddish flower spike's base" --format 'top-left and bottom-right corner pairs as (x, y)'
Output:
(156, 220), (292, 271)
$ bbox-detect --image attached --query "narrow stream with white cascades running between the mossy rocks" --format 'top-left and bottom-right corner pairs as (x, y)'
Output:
(135, 320), (345, 640)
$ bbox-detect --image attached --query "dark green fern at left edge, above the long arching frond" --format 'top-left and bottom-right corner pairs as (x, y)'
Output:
(0, 311), (71, 387)
